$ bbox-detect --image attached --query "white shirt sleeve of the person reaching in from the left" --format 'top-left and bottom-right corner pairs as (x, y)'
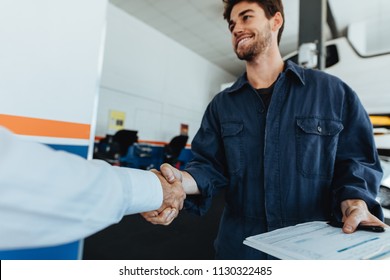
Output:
(0, 127), (163, 250)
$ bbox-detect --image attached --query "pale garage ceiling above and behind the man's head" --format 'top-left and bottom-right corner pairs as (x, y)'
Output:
(110, 0), (390, 76)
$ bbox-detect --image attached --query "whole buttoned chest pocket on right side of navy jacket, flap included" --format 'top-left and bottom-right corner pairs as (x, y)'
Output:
(296, 117), (344, 179)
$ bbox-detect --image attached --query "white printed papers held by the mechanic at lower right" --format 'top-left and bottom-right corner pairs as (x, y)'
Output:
(244, 222), (390, 260)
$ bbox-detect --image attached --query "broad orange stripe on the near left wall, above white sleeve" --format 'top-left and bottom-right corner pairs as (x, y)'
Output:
(0, 114), (91, 139)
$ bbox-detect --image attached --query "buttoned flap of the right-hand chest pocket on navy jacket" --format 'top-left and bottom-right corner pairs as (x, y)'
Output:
(297, 118), (344, 136)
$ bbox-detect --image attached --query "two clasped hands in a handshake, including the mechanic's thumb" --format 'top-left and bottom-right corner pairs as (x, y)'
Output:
(141, 163), (186, 225)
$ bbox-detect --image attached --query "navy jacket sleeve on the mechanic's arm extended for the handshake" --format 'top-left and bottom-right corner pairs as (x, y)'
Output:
(185, 100), (228, 215)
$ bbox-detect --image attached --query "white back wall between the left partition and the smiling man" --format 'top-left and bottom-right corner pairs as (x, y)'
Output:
(96, 4), (235, 142)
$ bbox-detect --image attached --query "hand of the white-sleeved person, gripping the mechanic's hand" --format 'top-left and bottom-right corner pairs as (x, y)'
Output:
(141, 170), (186, 225)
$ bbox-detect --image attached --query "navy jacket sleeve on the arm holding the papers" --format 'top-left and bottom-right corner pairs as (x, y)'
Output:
(333, 85), (383, 220)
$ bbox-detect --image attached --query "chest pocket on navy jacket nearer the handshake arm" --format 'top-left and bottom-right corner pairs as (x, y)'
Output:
(221, 122), (244, 174)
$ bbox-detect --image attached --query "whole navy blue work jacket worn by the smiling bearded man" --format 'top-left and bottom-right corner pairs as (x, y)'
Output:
(185, 62), (383, 259)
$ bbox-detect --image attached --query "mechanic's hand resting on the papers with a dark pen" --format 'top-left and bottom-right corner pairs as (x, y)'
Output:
(341, 199), (388, 233)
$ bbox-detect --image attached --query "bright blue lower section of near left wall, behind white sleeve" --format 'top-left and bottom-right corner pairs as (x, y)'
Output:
(0, 145), (88, 260)
